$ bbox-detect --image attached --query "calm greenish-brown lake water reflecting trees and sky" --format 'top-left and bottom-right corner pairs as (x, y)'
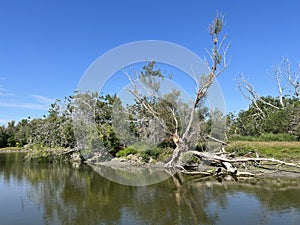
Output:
(0, 153), (300, 225)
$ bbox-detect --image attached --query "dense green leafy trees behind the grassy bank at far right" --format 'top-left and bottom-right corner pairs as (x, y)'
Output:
(229, 96), (300, 138)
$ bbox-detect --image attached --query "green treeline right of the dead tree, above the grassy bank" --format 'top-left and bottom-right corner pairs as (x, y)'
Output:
(227, 96), (300, 141)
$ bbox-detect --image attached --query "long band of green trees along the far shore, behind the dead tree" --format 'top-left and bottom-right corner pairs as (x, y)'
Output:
(0, 85), (300, 150)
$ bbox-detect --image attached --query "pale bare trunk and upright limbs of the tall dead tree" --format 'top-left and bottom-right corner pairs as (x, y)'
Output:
(124, 15), (230, 167)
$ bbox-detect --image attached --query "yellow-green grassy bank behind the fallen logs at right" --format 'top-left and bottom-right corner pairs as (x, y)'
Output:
(226, 141), (300, 162)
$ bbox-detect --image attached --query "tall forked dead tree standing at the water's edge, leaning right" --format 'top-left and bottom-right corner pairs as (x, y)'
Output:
(124, 12), (229, 167)
